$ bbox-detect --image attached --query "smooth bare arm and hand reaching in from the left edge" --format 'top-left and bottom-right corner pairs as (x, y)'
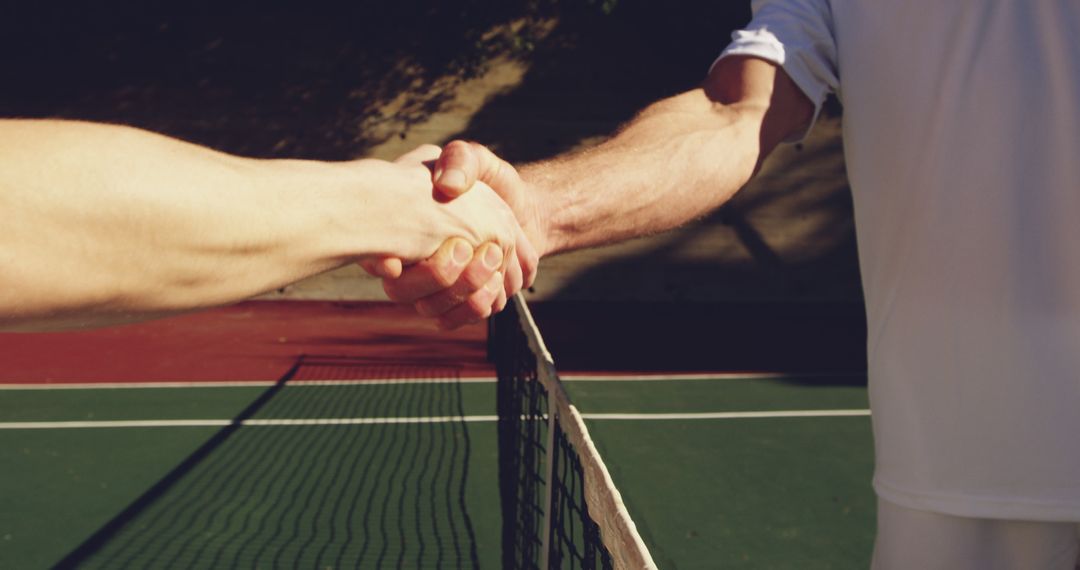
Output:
(0, 120), (516, 330)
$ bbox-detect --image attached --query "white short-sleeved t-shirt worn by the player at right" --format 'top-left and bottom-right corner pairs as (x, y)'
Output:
(721, 0), (1080, 520)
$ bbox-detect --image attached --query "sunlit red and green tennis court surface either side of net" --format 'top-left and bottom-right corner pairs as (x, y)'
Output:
(0, 303), (874, 568)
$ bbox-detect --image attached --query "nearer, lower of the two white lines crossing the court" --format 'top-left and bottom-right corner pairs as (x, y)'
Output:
(0, 409), (870, 430)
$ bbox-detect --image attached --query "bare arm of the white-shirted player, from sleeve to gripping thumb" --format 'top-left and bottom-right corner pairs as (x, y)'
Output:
(386, 57), (813, 324)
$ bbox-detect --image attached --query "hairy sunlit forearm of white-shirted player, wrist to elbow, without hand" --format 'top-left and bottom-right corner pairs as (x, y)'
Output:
(521, 90), (764, 253)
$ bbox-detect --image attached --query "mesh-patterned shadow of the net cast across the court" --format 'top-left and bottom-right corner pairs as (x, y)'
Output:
(57, 356), (480, 568)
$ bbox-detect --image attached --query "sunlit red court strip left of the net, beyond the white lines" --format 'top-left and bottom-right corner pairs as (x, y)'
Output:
(0, 301), (492, 383)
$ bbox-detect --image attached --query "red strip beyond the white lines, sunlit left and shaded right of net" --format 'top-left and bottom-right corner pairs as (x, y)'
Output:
(0, 301), (866, 384)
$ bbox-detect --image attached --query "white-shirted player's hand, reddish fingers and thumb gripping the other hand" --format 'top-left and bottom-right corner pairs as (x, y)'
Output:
(364, 141), (542, 328)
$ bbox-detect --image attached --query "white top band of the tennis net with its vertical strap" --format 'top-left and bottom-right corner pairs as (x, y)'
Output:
(513, 294), (657, 570)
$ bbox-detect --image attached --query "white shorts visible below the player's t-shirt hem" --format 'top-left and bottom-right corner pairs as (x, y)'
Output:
(870, 499), (1080, 570)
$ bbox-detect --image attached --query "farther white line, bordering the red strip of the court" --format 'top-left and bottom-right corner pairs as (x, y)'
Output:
(0, 372), (866, 391)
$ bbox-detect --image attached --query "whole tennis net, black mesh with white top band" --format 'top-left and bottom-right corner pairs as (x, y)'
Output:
(488, 295), (656, 570)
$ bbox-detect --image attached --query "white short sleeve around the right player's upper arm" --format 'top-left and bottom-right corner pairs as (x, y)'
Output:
(713, 0), (840, 140)
